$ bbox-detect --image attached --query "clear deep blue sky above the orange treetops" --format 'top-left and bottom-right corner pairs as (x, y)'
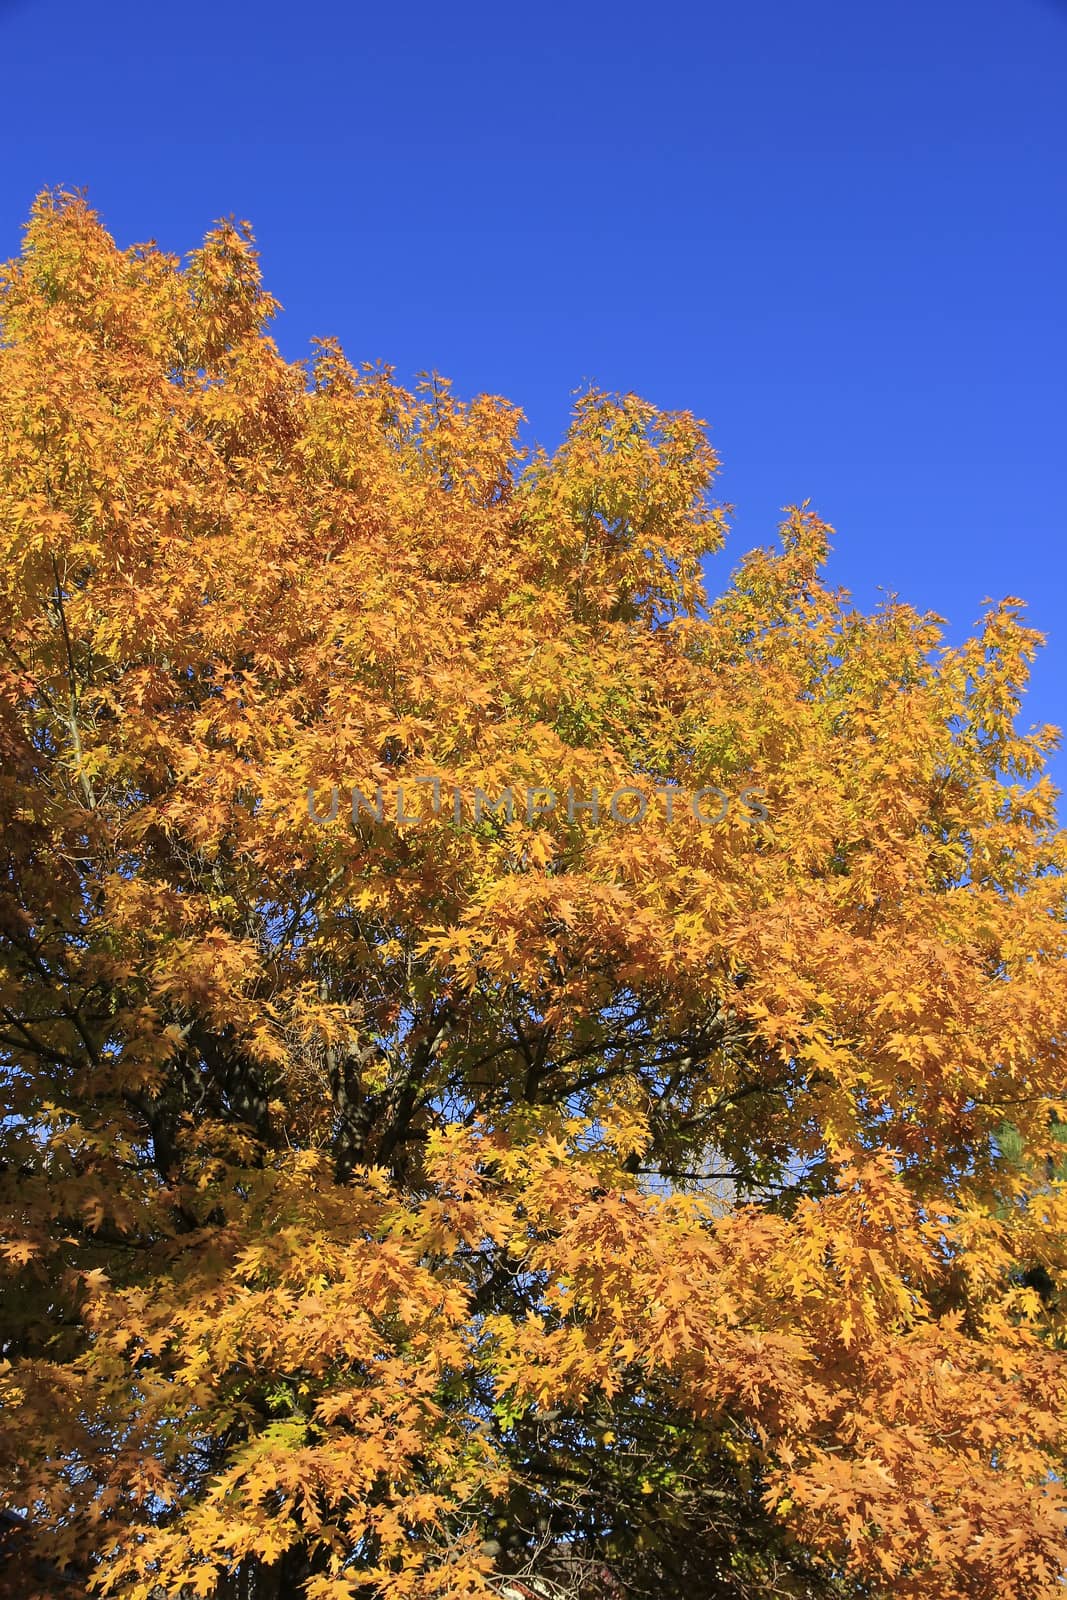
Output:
(0, 0), (1067, 786)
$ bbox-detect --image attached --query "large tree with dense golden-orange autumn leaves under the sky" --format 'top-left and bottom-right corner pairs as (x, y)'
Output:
(0, 195), (1067, 1600)
